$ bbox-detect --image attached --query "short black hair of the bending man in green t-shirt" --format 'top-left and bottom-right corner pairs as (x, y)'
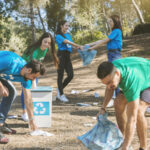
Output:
(97, 61), (114, 79)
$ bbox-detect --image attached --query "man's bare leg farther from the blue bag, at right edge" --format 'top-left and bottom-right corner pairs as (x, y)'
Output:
(136, 101), (149, 150)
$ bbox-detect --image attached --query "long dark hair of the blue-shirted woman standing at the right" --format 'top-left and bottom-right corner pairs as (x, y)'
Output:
(110, 15), (122, 31)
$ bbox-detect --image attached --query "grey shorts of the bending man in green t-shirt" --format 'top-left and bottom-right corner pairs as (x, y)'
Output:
(140, 88), (150, 104)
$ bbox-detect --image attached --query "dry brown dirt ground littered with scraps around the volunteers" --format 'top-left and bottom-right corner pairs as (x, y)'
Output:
(0, 34), (150, 150)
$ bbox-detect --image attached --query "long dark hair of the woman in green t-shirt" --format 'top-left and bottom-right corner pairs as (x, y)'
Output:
(24, 32), (58, 68)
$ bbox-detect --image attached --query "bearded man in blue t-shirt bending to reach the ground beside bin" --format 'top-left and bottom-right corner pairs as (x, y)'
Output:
(0, 51), (45, 144)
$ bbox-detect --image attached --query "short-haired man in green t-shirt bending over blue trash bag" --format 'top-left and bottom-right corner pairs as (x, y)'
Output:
(97, 57), (150, 150)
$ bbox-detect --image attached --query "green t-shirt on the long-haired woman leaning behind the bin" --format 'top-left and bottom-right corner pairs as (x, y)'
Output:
(22, 47), (48, 62)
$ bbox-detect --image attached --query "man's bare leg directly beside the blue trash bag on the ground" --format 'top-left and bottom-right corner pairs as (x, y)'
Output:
(114, 93), (127, 136)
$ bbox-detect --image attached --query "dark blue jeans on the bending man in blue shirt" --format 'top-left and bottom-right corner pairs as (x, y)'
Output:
(0, 78), (17, 123)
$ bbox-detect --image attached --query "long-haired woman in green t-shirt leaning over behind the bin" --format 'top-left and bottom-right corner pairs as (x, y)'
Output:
(21, 32), (58, 121)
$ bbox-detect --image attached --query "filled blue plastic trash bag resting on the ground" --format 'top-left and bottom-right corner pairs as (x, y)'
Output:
(77, 113), (123, 150)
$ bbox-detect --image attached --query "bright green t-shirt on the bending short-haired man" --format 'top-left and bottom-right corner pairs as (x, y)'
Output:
(113, 57), (150, 102)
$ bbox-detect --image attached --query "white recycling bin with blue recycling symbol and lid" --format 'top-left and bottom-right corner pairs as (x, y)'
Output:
(31, 86), (53, 127)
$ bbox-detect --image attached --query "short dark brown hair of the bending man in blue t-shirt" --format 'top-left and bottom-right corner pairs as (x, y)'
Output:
(25, 60), (46, 75)
